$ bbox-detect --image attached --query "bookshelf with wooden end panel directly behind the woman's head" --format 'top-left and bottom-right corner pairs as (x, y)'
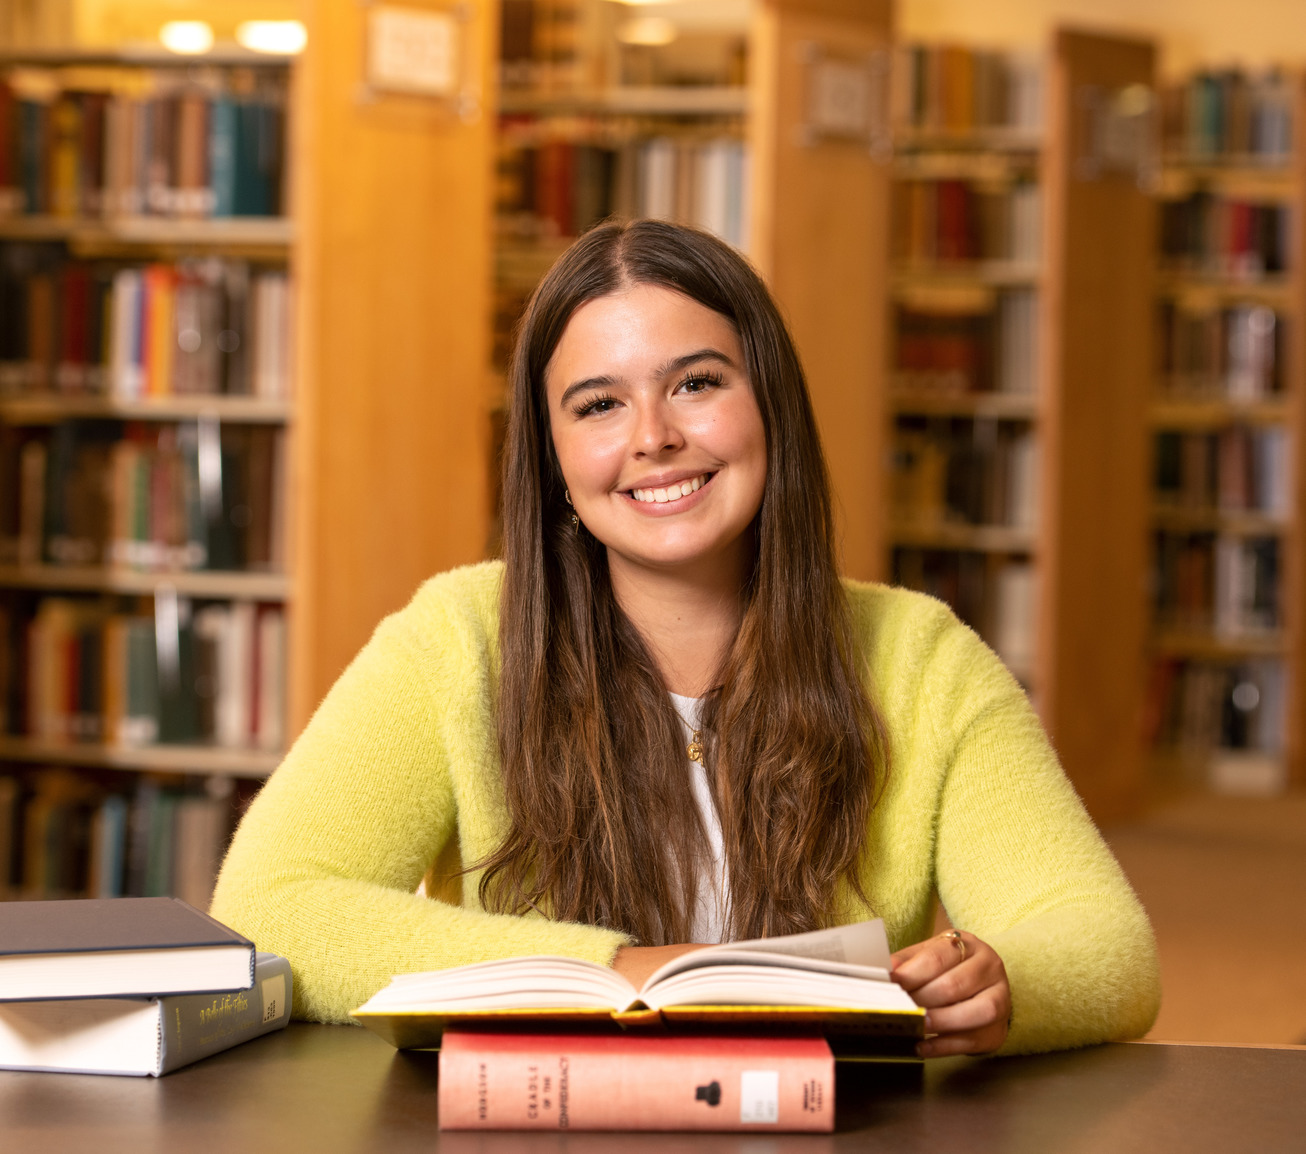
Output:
(488, 0), (891, 577)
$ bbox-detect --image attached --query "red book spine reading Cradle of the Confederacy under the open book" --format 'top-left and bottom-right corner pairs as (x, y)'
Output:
(439, 1031), (835, 1133)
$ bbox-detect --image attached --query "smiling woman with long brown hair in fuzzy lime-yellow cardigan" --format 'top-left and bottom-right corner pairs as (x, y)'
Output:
(213, 221), (1158, 1056)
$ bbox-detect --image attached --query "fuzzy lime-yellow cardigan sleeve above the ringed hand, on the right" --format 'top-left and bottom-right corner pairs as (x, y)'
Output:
(934, 613), (1160, 1052)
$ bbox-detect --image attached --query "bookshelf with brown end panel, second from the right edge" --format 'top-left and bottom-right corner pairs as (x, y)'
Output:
(884, 30), (1155, 819)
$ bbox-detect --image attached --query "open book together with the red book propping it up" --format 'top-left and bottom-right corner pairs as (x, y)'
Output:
(354, 919), (925, 1133)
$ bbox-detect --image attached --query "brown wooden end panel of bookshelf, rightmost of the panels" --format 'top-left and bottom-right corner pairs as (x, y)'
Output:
(1037, 31), (1156, 820)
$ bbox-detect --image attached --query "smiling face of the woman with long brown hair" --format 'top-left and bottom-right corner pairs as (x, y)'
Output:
(545, 285), (767, 577)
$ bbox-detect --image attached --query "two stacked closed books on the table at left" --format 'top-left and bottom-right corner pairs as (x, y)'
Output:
(0, 898), (291, 1077)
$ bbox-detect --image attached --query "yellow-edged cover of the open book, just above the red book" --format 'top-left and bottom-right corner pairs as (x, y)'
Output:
(350, 1005), (925, 1061)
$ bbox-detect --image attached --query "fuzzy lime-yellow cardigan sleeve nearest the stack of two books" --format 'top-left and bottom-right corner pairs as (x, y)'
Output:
(212, 582), (627, 1022)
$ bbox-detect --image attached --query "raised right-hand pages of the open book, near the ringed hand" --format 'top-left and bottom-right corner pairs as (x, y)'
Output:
(643, 918), (889, 990)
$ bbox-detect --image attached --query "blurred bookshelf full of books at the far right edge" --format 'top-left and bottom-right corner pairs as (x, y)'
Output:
(1147, 69), (1306, 794)
